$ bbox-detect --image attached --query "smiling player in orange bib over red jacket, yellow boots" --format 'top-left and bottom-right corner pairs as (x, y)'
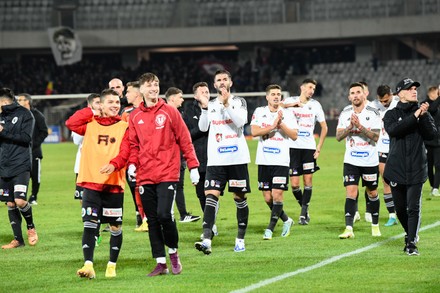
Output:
(66, 89), (130, 279)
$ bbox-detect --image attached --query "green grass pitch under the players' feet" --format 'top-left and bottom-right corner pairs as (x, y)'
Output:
(0, 137), (440, 292)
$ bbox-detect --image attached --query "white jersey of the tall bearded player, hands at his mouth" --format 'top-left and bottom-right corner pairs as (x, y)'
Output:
(199, 96), (251, 166)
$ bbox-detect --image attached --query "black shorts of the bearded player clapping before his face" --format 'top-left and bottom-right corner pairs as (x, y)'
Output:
(205, 164), (251, 193)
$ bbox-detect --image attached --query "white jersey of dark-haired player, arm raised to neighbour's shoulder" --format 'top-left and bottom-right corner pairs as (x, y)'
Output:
(283, 96), (325, 150)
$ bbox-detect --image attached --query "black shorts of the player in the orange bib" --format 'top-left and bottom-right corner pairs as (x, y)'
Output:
(81, 188), (124, 225)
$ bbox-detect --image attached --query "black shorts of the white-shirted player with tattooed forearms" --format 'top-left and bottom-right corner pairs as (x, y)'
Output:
(344, 163), (379, 190)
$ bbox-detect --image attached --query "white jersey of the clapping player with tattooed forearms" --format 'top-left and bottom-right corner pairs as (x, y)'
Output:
(337, 106), (382, 167)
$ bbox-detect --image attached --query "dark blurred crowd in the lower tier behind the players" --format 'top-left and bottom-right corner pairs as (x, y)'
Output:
(0, 46), (354, 95)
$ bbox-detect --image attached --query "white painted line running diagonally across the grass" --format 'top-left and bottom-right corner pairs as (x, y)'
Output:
(231, 221), (440, 293)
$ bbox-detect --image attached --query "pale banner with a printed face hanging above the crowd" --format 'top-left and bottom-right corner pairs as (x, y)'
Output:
(47, 26), (82, 66)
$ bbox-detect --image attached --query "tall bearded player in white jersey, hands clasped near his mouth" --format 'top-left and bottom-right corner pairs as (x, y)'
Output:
(194, 70), (251, 254)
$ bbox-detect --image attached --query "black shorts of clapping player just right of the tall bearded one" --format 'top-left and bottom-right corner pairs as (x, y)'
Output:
(258, 165), (289, 191)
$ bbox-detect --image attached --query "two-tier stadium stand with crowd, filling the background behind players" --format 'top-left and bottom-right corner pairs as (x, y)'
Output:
(0, 0), (440, 137)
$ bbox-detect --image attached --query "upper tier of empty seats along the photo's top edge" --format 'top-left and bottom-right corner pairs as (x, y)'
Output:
(0, 0), (440, 31)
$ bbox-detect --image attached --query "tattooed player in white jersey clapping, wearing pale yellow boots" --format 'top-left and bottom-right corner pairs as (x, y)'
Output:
(336, 83), (381, 239)
